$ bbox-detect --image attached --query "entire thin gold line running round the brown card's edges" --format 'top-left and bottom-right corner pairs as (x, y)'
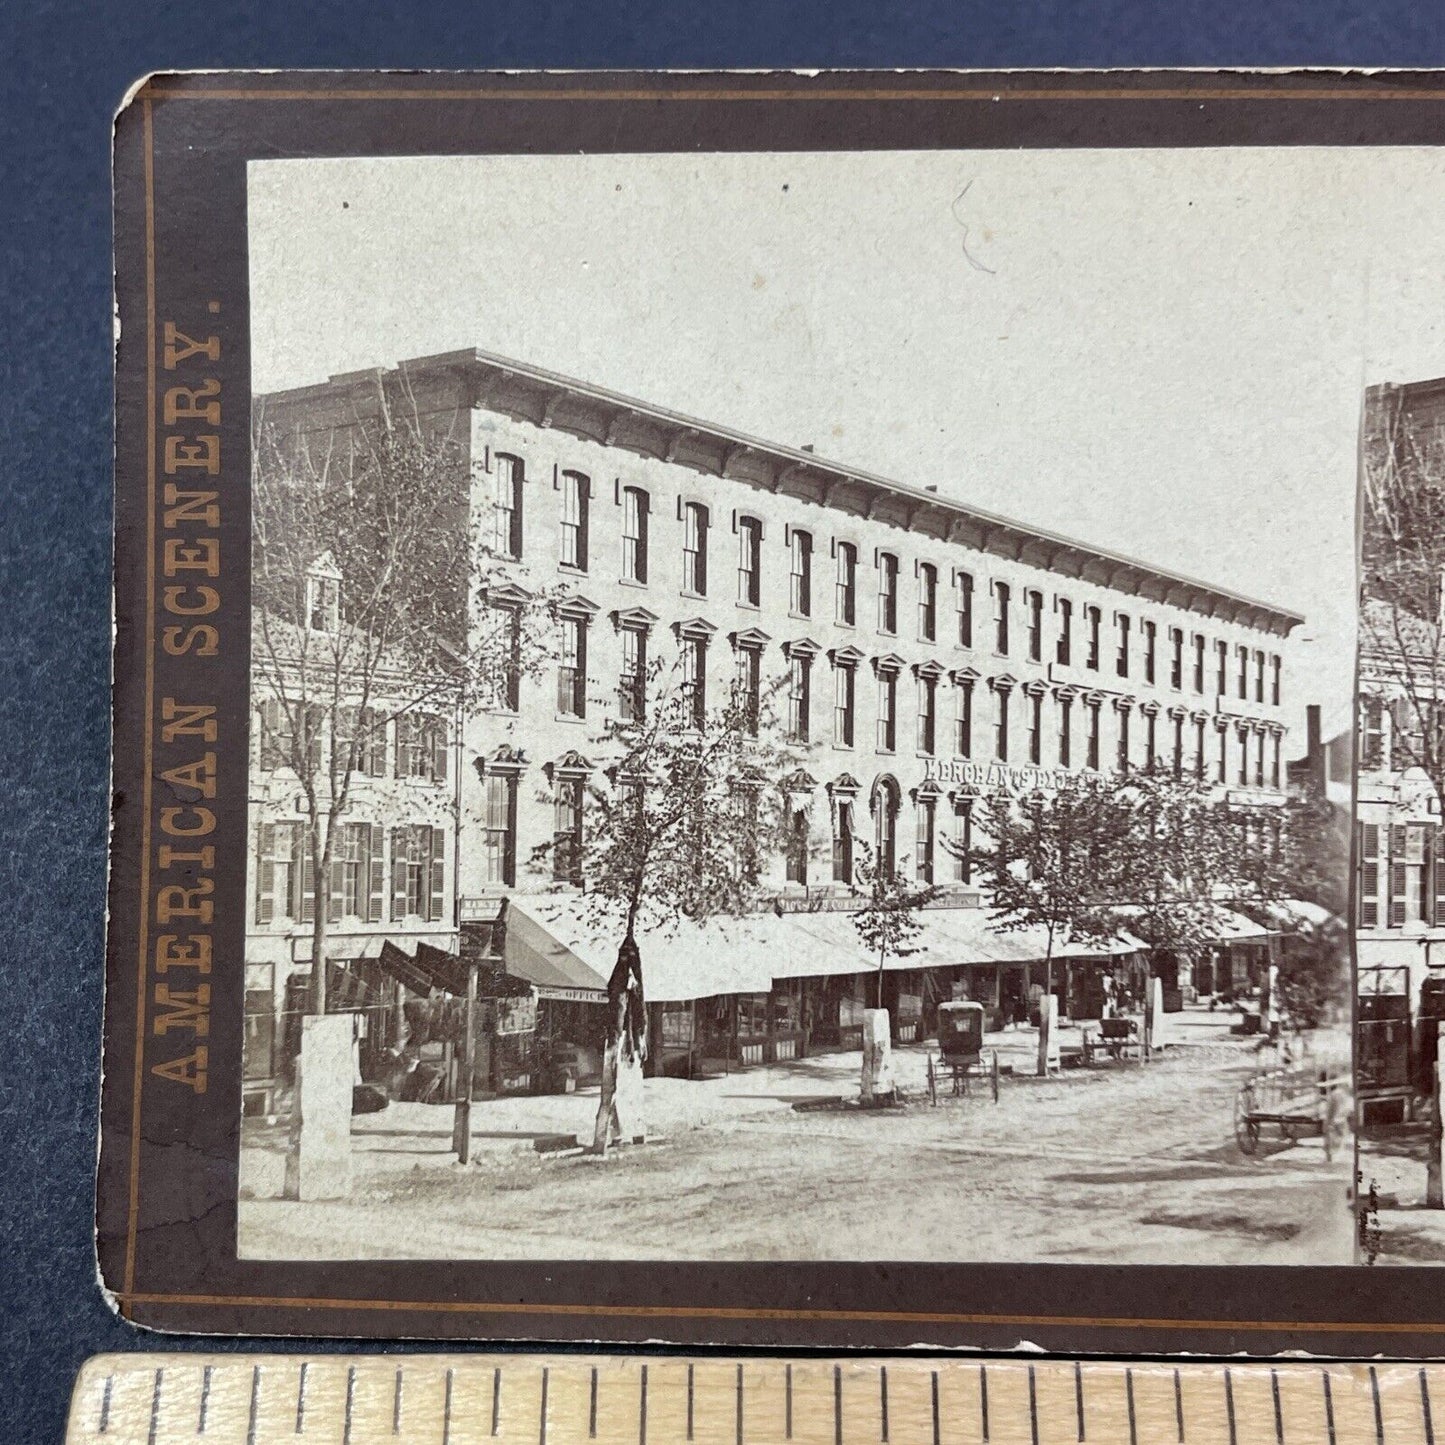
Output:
(117, 65), (1445, 1335)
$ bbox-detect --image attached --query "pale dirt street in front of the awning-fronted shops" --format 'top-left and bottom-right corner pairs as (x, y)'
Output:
(240, 1030), (1353, 1264)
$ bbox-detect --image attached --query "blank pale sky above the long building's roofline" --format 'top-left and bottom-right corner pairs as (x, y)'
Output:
(249, 149), (1445, 751)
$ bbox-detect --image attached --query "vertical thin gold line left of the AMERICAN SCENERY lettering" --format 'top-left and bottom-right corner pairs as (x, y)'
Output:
(126, 97), (156, 1290)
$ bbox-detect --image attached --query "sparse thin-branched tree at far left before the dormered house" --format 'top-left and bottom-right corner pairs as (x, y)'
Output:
(251, 406), (546, 1013)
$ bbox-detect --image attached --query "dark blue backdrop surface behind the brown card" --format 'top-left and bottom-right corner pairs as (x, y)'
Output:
(8, 0), (1445, 1441)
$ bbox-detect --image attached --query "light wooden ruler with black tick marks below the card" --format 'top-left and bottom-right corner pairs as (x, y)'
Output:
(66, 1354), (1445, 1445)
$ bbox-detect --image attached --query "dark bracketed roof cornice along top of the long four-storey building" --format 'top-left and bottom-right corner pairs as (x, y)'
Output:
(257, 350), (1305, 637)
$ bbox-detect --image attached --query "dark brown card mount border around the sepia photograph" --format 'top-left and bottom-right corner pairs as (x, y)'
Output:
(98, 72), (1445, 1354)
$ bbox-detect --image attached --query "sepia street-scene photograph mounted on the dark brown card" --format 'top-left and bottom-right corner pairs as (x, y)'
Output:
(225, 147), (1421, 1264)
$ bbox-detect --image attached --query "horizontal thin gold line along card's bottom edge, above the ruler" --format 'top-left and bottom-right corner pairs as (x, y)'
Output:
(118, 1294), (1445, 1335)
